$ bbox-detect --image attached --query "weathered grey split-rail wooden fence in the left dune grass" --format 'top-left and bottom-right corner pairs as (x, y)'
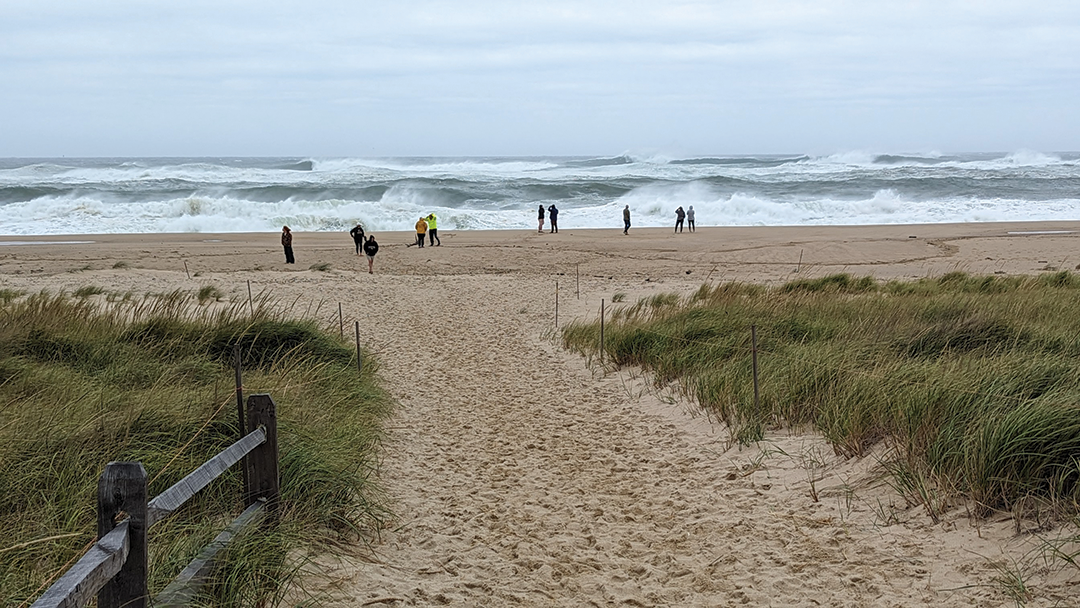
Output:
(31, 393), (279, 608)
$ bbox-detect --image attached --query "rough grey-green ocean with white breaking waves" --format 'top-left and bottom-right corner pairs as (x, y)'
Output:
(0, 151), (1080, 235)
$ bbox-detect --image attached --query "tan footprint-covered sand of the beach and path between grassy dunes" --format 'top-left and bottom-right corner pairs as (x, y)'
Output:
(0, 222), (1080, 607)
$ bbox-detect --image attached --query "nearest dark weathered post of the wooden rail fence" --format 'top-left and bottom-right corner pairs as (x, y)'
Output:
(97, 462), (149, 608)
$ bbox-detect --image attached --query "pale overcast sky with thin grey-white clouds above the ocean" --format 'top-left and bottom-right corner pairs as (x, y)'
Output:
(0, 0), (1080, 157)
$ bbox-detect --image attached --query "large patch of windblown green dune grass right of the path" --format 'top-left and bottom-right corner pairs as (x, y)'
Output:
(563, 272), (1080, 516)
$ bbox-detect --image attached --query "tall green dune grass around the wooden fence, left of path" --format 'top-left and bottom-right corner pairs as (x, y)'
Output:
(0, 292), (390, 606)
